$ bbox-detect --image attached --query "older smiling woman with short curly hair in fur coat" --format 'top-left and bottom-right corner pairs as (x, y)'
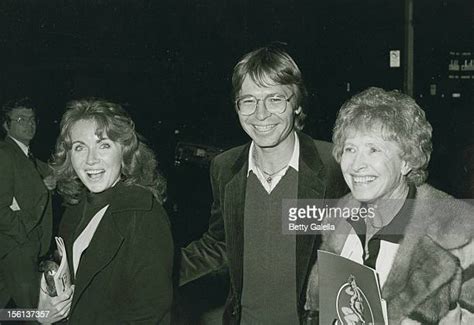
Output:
(305, 88), (474, 324)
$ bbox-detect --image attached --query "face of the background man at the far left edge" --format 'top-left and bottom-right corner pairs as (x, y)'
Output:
(4, 108), (36, 146)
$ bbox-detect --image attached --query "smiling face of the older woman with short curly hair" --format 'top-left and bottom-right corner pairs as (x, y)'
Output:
(341, 132), (410, 203)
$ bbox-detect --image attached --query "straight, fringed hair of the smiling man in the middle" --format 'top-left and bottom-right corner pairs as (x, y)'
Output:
(232, 45), (307, 130)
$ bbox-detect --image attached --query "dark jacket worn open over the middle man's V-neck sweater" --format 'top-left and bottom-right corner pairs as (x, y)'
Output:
(180, 133), (346, 324)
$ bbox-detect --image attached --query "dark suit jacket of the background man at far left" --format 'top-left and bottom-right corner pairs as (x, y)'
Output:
(0, 137), (52, 259)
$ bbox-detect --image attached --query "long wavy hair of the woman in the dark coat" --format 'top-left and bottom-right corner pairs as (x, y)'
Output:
(50, 99), (166, 204)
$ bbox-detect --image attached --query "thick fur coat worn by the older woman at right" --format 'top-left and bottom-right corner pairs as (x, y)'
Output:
(306, 184), (474, 325)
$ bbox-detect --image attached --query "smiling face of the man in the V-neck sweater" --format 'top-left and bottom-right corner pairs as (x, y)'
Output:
(238, 76), (301, 148)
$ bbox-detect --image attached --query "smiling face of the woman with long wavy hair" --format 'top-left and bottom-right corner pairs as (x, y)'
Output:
(70, 120), (122, 193)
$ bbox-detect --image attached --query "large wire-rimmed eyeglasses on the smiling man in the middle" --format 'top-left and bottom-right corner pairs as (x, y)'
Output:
(235, 94), (294, 115)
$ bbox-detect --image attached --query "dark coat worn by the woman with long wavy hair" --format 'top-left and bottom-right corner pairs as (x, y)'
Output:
(60, 184), (173, 324)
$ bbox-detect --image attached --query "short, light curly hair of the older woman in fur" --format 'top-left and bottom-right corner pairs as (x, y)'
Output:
(332, 87), (433, 185)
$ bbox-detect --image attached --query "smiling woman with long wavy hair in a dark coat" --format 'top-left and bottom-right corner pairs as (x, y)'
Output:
(39, 100), (173, 324)
